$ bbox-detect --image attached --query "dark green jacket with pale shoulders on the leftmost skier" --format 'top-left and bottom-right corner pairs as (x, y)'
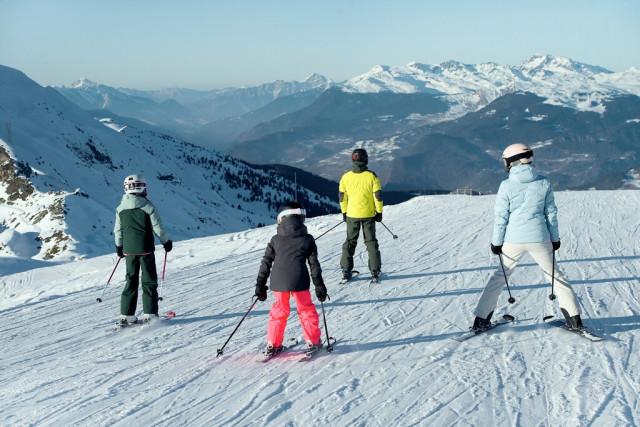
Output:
(113, 194), (169, 255)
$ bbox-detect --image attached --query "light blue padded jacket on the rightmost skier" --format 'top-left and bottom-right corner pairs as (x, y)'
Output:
(491, 164), (560, 246)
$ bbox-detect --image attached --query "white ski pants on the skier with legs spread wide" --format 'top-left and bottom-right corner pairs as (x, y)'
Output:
(475, 242), (580, 319)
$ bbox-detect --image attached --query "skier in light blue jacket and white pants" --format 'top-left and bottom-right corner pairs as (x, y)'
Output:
(472, 143), (584, 330)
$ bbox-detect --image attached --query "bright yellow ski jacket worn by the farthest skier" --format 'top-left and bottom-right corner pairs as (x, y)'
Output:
(338, 162), (382, 218)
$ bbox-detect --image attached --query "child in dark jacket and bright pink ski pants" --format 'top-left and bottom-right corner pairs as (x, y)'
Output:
(255, 202), (327, 355)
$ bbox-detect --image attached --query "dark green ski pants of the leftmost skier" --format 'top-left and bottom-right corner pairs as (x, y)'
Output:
(120, 252), (158, 316)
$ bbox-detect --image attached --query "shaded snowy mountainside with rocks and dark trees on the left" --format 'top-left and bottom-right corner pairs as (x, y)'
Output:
(0, 66), (337, 261)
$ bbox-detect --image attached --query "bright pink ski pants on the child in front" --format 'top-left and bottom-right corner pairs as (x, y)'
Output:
(267, 290), (321, 347)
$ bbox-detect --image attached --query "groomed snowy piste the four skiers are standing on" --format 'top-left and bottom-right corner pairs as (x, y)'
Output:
(0, 191), (640, 426)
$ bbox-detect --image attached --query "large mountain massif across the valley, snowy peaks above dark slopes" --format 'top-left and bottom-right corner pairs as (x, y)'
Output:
(55, 54), (640, 192)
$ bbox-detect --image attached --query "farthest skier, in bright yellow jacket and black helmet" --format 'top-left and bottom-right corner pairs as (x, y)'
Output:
(338, 148), (382, 281)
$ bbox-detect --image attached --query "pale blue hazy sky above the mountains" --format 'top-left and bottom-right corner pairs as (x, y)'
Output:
(0, 0), (640, 89)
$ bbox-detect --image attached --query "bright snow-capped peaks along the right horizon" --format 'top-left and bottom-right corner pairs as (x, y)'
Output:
(343, 54), (640, 116)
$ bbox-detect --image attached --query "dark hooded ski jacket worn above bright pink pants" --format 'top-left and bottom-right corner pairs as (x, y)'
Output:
(257, 216), (324, 292)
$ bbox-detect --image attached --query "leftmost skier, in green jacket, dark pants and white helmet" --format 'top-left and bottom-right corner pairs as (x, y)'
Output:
(113, 175), (173, 325)
